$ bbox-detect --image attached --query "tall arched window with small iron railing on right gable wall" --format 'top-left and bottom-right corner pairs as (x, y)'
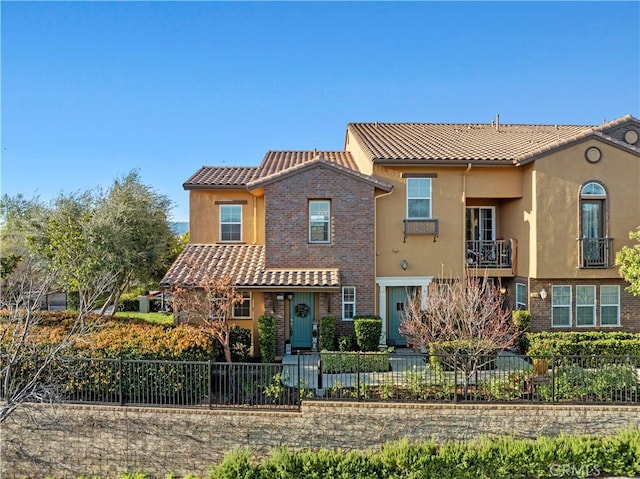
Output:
(579, 181), (610, 268)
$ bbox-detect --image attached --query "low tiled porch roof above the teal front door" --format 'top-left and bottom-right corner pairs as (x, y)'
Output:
(160, 244), (340, 290)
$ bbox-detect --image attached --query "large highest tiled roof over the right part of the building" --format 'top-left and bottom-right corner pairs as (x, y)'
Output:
(347, 115), (637, 165)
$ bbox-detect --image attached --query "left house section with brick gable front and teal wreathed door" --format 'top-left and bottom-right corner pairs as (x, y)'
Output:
(161, 151), (391, 354)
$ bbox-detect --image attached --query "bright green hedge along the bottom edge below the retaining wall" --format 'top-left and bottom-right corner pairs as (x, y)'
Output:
(209, 430), (640, 479)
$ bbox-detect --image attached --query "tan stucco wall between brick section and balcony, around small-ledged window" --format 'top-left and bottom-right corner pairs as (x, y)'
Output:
(374, 166), (523, 278)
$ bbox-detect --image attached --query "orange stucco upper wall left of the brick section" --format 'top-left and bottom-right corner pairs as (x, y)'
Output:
(189, 190), (264, 244)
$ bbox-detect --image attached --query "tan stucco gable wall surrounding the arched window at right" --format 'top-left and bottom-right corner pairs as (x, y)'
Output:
(531, 139), (640, 279)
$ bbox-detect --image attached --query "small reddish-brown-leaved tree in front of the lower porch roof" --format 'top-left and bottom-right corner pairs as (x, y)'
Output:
(172, 275), (243, 363)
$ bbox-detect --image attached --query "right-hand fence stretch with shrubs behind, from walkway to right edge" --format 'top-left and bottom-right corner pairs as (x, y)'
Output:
(300, 352), (640, 404)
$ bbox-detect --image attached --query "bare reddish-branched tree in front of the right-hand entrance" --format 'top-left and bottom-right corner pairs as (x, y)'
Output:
(400, 274), (518, 393)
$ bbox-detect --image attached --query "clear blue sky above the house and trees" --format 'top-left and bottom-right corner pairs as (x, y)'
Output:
(0, 1), (640, 221)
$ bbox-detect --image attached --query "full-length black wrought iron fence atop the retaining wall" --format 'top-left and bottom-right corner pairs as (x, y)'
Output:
(5, 352), (640, 409)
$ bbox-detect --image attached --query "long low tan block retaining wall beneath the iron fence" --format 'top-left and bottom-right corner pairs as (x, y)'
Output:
(0, 401), (640, 479)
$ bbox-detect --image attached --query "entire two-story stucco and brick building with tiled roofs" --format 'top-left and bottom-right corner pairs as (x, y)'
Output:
(162, 115), (640, 358)
